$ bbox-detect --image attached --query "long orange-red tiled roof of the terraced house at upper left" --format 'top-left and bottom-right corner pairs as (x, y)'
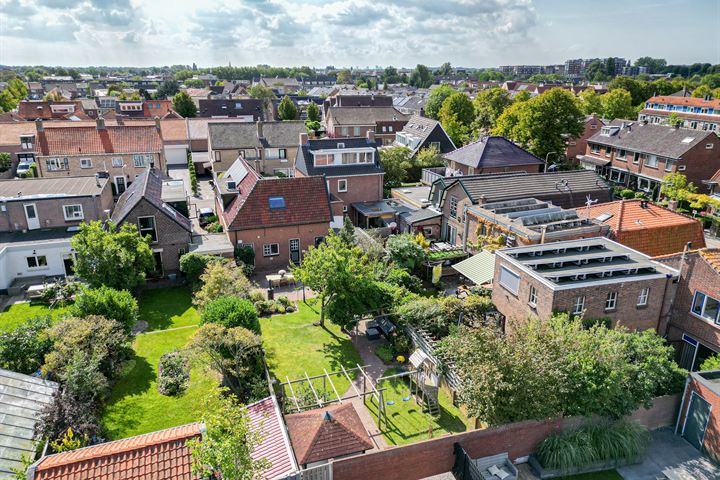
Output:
(38, 125), (162, 155)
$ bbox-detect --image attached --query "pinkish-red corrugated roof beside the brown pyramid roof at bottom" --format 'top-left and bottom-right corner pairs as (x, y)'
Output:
(247, 397), (297, 480)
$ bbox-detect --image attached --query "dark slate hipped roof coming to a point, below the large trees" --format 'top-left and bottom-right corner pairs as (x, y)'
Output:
(443, 136), (544, 168)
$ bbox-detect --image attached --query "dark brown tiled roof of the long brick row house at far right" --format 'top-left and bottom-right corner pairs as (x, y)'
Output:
(588, 119), (715, 158)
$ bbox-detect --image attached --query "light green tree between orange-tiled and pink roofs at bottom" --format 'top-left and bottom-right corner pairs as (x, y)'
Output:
(186, 390), (269, 480)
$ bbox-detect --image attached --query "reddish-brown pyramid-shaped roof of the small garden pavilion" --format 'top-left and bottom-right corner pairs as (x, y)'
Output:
(285, 403), (373, 465)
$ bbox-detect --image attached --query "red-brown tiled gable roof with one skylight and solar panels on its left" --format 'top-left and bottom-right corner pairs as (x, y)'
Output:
(222, 158), (332, 230)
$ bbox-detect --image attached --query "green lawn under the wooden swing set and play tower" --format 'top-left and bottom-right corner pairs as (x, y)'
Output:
(366, 368), (470, 445)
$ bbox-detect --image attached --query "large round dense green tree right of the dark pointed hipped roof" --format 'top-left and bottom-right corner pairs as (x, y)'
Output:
(493, 88), (585, 158)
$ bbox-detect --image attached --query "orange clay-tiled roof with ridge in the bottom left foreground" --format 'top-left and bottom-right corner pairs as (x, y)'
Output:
(31, 423), (200, 480)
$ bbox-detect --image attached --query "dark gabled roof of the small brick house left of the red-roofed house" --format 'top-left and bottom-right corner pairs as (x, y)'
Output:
(110, 169), (192, 232)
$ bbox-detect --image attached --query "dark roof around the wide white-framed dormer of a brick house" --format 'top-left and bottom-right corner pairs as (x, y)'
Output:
(295, 137), (383, 177)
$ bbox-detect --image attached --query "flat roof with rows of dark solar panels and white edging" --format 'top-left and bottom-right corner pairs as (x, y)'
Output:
(497, 237), (678, 290)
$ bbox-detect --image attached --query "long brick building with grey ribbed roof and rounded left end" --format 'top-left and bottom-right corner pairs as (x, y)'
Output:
(429, 170), (611, 245)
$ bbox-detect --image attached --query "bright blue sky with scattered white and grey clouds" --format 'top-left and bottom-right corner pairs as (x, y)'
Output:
(0, 0), (720, 68)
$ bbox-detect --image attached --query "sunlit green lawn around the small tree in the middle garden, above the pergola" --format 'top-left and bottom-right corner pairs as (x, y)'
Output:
(260, 302), (361, 397)
